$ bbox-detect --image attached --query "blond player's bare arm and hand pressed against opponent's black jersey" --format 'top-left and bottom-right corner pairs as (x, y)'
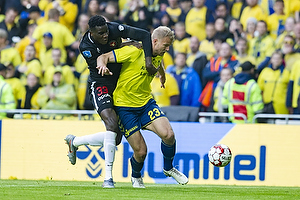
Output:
(96, 51), (116, 76)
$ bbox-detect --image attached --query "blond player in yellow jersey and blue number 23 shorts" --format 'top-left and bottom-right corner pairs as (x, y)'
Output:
(97, 26), (188, 188)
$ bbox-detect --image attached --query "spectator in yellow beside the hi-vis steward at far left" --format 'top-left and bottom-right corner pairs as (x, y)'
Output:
(5, 63), (25, 109)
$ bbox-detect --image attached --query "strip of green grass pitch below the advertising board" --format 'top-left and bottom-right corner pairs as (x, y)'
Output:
(0, 180), (300, 200)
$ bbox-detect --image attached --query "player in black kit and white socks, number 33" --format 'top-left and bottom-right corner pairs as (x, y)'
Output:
(65, 15), (157, 188)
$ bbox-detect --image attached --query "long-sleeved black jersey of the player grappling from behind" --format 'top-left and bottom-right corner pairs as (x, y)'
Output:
(79, 22), (152, 85)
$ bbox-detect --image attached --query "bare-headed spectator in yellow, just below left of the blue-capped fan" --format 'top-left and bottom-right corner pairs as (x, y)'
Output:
(16, 44), (42, 86)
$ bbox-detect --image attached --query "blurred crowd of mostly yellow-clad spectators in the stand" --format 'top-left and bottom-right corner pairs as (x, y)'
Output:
(0, 0), (300, 123)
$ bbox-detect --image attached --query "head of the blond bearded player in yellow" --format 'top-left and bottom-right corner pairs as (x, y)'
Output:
(152, 26), (175, 56)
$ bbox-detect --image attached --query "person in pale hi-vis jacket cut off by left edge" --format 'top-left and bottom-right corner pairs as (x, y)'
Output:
(0, 63), (16, 119)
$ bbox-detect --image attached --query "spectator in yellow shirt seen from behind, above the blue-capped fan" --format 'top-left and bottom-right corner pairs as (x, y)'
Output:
(32, 9), (79, 65)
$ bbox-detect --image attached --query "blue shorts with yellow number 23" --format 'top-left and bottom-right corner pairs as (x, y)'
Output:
(115, 99), (165, 138)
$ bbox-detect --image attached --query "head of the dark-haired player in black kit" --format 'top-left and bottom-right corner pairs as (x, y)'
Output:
(89, 15), (109, 44)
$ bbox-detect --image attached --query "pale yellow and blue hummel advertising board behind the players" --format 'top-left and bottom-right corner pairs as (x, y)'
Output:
(0, 119), (300, 186)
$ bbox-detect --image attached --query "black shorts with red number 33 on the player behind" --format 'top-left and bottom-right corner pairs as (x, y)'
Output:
(88, 81), (115, 115)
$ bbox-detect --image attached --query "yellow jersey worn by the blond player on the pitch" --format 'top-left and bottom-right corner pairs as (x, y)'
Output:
(113, 46), (163, 107)
